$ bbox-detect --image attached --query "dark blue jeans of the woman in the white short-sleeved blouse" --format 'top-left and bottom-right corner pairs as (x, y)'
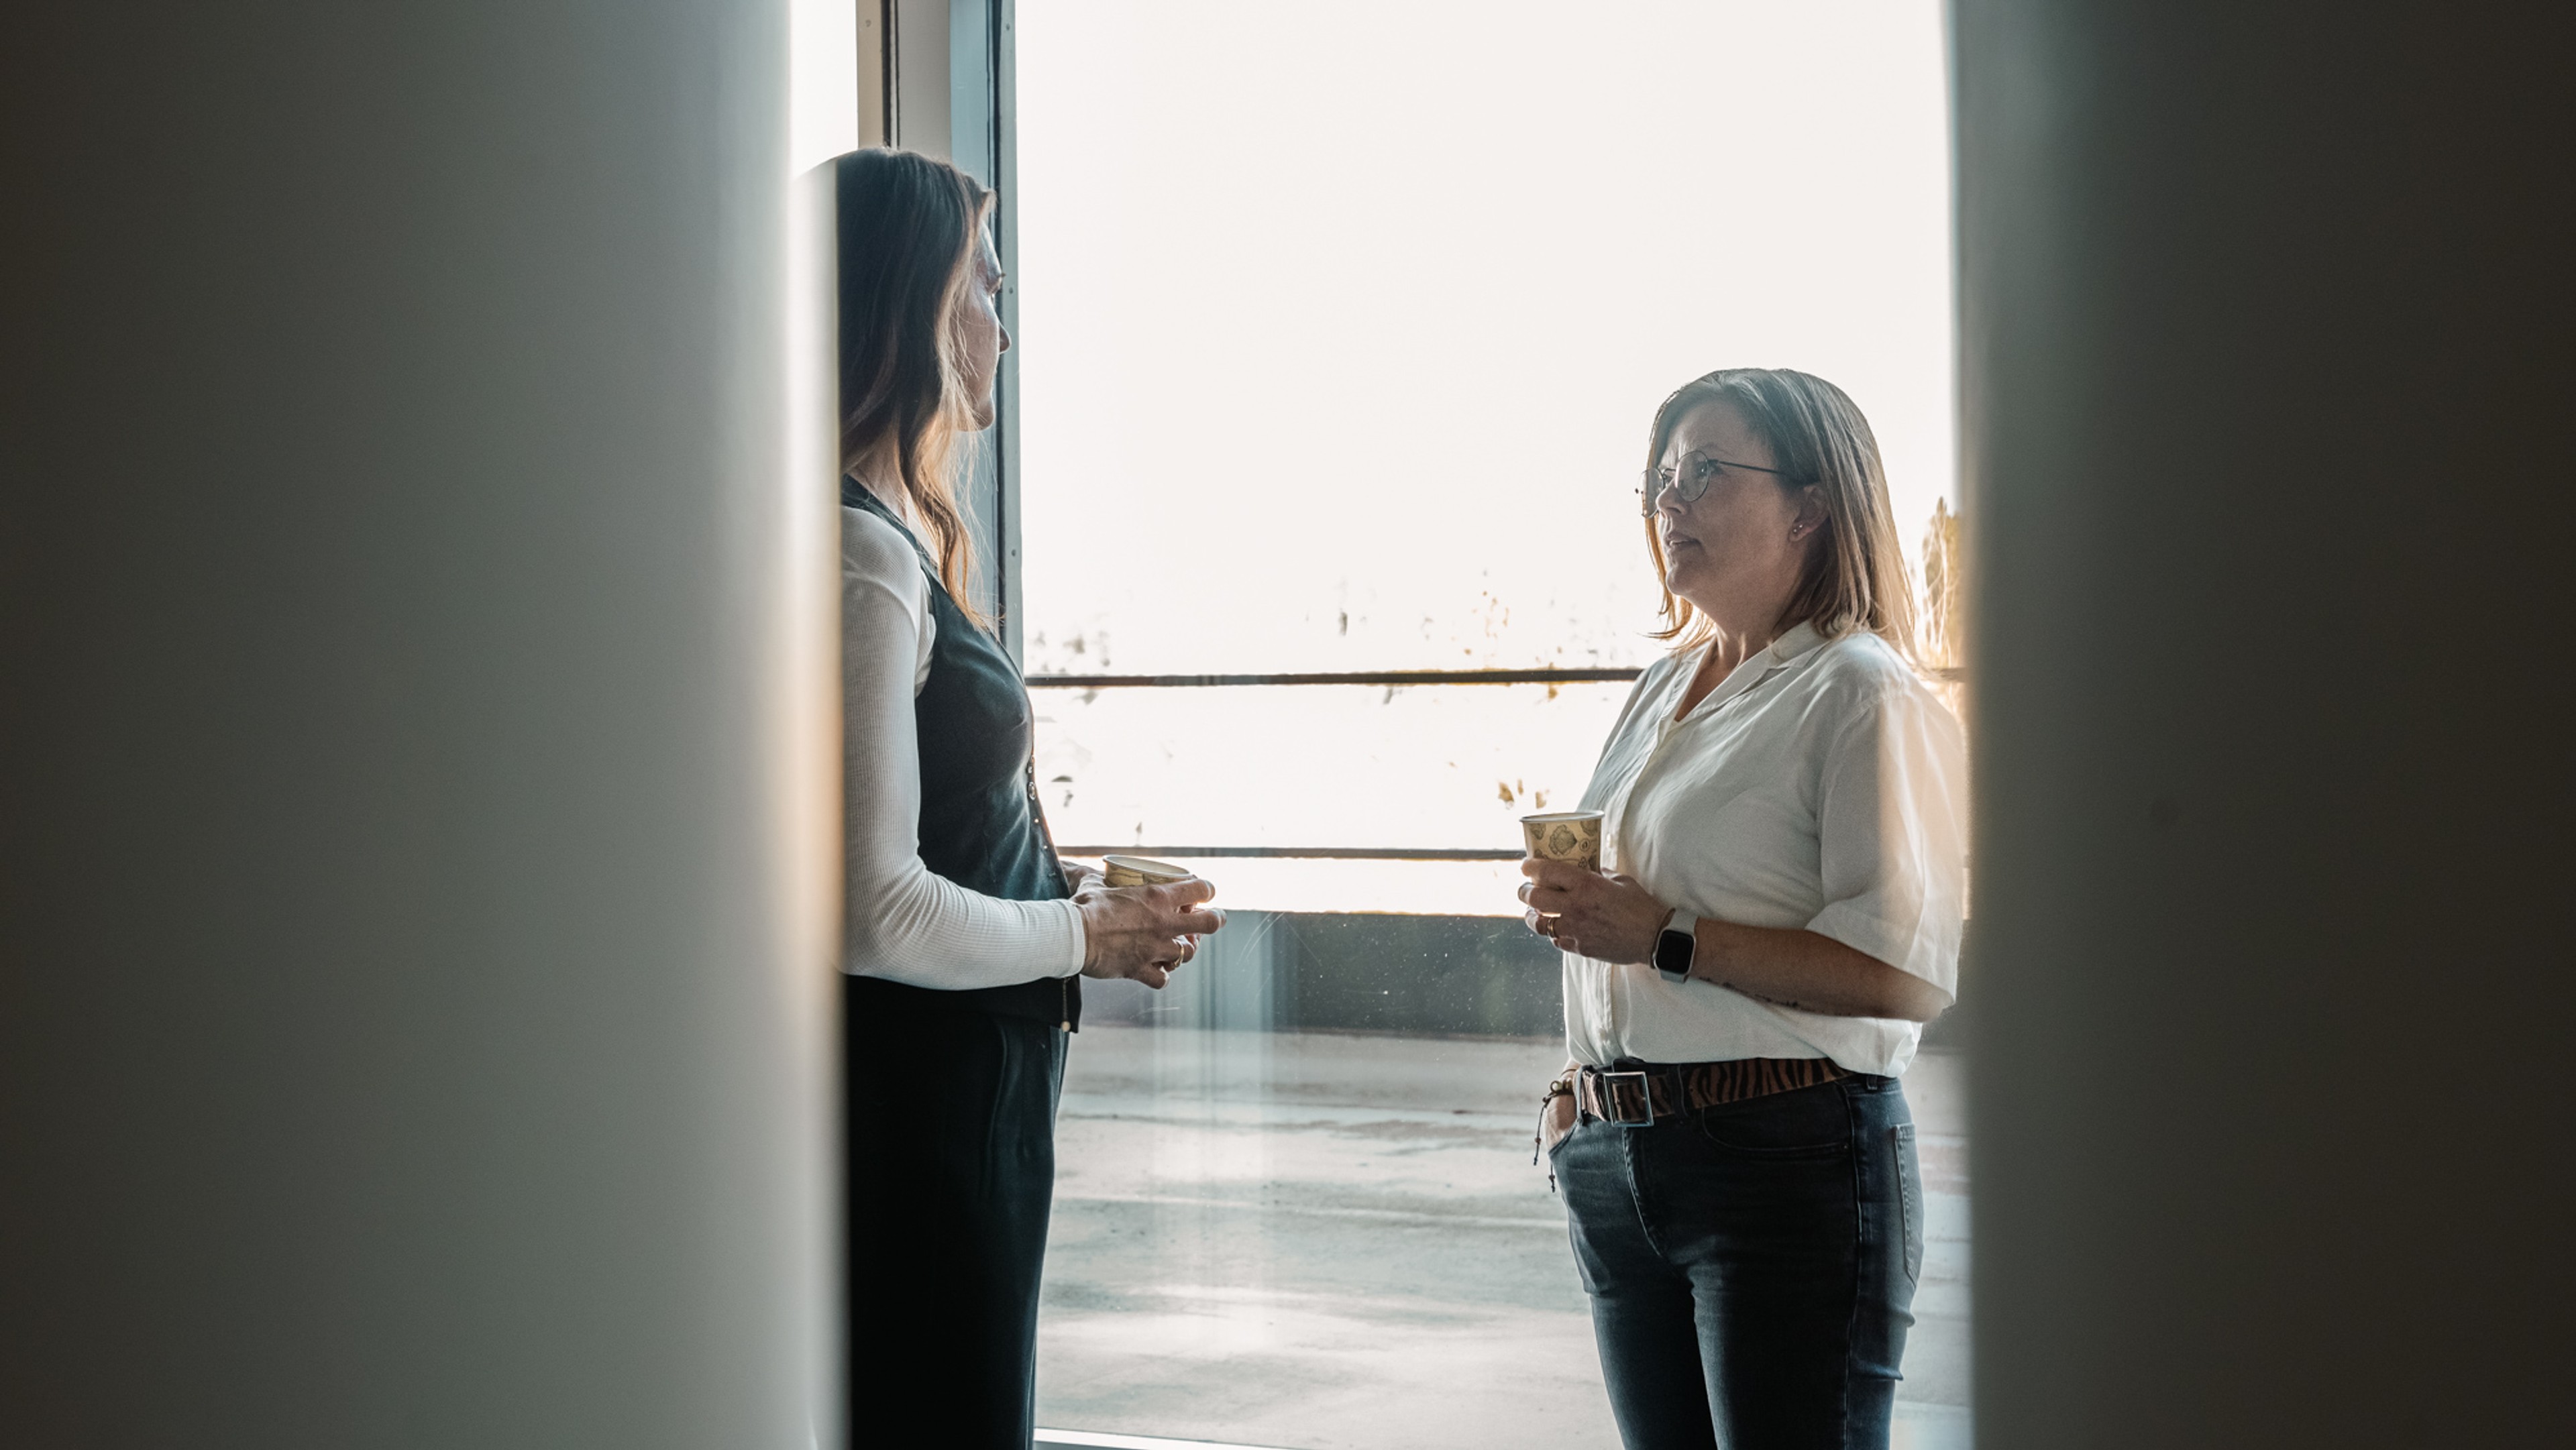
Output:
(1551, 1076), (1924, 1450)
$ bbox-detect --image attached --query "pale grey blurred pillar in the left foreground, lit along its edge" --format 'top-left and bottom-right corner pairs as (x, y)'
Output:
(0, 0), (840, 1450)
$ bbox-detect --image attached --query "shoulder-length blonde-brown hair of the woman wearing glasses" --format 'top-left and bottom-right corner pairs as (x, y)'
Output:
(1646, 368), (1917, 662)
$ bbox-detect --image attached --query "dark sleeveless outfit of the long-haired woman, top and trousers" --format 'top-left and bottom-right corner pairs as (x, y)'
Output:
(840, 479), (1082, 1450)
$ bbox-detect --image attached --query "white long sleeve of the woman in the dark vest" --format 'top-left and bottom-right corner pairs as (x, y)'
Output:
(840, 508), (1082, 991)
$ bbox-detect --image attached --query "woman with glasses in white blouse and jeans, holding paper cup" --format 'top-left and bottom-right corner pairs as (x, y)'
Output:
(1520, 368), (1966, 1450)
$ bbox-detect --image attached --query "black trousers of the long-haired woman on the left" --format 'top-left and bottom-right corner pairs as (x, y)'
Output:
(843, 984), (1064, 1450)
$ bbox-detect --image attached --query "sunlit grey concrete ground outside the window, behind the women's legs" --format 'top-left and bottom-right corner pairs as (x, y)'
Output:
(1038, 1025), (1968, 1450)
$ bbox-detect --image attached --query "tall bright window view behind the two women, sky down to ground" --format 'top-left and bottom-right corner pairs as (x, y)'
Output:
(1015, 0), (1966, 1450)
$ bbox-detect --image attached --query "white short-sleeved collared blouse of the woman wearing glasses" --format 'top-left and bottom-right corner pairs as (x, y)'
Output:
(1564, 626), (1968, 1074)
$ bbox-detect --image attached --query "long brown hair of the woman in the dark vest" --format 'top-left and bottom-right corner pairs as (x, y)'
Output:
(832, 147), (991, 626)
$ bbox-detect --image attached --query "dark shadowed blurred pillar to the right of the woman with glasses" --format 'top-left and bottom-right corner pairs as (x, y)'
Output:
(1955, 0), (2576, 1450)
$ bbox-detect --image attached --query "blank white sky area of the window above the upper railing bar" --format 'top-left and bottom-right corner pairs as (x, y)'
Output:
(1018, 0), (1953, 675)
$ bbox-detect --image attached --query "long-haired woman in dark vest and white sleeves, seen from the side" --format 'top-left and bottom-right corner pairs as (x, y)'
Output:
(832, 150), (1224, 1450)
